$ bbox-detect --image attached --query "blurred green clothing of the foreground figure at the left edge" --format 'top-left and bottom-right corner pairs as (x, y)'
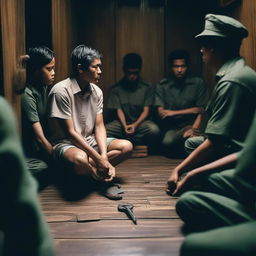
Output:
(0, 98), (54, 256)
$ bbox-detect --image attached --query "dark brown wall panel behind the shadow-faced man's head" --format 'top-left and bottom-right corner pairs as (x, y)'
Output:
(116, 6), (165, 83)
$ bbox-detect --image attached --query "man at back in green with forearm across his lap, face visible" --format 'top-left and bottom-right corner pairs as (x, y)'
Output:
(154, 49), (207, 157)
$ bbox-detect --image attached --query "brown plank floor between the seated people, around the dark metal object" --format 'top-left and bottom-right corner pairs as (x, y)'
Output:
(40, 156), (183, 256)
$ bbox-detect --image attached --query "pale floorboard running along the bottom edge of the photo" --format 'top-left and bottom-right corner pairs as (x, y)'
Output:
(55, 238), (183, 256)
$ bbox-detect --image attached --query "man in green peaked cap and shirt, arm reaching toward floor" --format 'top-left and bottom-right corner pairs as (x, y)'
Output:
(167, 14), (256, 193)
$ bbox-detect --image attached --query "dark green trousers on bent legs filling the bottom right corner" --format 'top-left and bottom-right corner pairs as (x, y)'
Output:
(176, 169), (256, 256)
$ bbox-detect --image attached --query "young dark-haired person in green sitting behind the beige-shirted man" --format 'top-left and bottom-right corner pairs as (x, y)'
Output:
(21, 46), (55, 189)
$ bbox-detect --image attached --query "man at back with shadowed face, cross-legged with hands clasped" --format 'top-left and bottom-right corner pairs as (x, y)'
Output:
(106, 53), (160, 153)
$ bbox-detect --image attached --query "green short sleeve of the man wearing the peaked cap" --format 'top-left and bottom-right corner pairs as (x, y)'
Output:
(205, 81), (255, 146)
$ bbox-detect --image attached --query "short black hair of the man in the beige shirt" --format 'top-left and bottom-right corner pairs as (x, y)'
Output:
(71, 44), (102, 77)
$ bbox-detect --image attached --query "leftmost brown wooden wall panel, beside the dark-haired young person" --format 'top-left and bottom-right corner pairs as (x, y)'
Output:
(0, 0), (25, 125)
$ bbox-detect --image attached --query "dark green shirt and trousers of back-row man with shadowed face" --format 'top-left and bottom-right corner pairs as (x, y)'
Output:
(106, 78), (160, 148)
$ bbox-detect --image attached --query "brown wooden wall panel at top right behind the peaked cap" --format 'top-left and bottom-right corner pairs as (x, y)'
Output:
(233, 0), (256, 70)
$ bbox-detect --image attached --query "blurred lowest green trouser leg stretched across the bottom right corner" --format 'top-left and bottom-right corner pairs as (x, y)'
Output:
(180, 221), (256, 256)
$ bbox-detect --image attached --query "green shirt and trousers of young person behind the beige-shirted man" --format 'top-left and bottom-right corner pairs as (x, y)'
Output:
(21, 85), (50, 187)
